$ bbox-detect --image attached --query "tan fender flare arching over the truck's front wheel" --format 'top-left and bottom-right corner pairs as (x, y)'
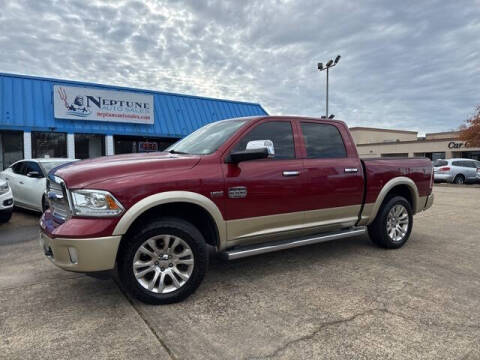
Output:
(112, 191), (227, 247)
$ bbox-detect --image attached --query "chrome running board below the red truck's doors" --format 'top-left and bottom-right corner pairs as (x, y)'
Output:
(222, 226), (367, 260)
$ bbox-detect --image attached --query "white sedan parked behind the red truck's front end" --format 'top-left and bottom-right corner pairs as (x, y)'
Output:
(0, 158), (76, 212)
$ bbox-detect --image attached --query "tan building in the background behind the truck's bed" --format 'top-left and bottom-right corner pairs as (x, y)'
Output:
(350, 127), (480, 160)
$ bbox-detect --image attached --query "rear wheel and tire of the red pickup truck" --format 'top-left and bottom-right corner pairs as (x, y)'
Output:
(368, 196), (413, 249)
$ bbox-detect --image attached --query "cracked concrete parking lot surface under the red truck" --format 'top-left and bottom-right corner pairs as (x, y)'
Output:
(0, 186), (480, 359)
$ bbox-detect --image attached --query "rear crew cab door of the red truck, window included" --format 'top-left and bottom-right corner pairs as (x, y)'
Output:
(297, 120), (364, 230)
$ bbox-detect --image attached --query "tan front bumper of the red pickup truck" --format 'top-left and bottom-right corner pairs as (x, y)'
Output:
(40, 231), (121, 272)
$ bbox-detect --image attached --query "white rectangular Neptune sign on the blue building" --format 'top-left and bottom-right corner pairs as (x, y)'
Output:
(53, 85), (154, 124)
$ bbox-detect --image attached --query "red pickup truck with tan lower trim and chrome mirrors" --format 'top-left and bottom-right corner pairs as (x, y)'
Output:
(40, 116), (433, 304)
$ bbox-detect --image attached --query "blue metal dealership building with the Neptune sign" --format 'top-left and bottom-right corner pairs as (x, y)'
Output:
(0, 73), (267, 170)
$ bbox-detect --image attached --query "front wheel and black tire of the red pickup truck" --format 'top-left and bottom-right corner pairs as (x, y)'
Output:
(118, 217), (208, 305)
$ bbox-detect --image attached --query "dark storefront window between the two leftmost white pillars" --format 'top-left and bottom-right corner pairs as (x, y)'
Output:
(32, 132), (67, 158)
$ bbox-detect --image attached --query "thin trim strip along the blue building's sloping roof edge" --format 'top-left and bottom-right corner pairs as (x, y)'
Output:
(0, 72), (268, 108)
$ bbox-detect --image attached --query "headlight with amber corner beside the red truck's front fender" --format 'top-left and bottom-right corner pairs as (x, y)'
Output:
(71, 190), (124, 217)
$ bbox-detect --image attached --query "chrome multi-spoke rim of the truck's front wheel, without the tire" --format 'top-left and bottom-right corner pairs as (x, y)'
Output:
(133, 235), (194, 294)
